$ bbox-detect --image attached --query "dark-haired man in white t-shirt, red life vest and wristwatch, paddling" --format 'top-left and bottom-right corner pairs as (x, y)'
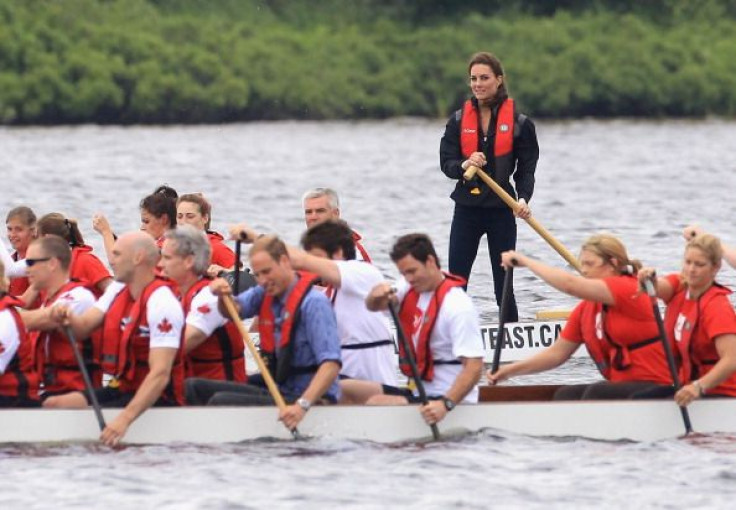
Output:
(366, 234), (484, 424)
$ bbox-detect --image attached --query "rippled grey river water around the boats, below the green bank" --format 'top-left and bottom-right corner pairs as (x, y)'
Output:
(0, 119), (736, 509)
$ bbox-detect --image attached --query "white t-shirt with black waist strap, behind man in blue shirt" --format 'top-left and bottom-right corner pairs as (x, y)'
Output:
(333, 260), (398, 386)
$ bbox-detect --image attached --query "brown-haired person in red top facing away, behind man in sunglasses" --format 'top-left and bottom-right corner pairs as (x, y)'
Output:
(37, 213), (112, 297)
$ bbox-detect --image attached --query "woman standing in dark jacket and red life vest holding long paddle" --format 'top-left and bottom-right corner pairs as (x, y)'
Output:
(440, 53), (539, 322)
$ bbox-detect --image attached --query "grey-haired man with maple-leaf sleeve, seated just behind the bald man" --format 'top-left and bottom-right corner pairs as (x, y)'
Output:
(159, 225), (246, 382)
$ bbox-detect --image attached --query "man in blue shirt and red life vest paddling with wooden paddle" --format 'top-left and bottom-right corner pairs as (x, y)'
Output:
(186, 236), (341, 429)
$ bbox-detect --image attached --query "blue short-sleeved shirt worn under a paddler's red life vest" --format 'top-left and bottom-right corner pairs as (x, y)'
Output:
(235, 282), (342, 400)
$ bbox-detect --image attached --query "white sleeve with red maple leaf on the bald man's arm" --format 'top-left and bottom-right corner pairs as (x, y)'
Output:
(146, 287), (184, 349)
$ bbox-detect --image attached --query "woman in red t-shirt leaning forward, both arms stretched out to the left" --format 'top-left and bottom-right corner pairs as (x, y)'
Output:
(488, 234), (672, 400)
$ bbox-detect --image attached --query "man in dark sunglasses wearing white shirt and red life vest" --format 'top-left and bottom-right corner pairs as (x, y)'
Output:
(21, 235), (102, 401)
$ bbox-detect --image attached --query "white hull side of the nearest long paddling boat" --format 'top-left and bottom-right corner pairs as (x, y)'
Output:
(0, 399), (736, 444)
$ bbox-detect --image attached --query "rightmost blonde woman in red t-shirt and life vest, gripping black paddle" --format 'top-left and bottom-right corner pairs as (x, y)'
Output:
(640, 234), (736, 406)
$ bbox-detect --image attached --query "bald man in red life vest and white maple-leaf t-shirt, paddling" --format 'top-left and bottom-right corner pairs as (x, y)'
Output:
(45, 232), (184, 446)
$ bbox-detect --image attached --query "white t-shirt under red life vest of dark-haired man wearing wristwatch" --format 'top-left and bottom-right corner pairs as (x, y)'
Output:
(396, 278), (485, 403)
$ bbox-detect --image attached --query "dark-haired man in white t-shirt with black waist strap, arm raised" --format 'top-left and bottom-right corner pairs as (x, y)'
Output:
(289, 220), (397, 390)
